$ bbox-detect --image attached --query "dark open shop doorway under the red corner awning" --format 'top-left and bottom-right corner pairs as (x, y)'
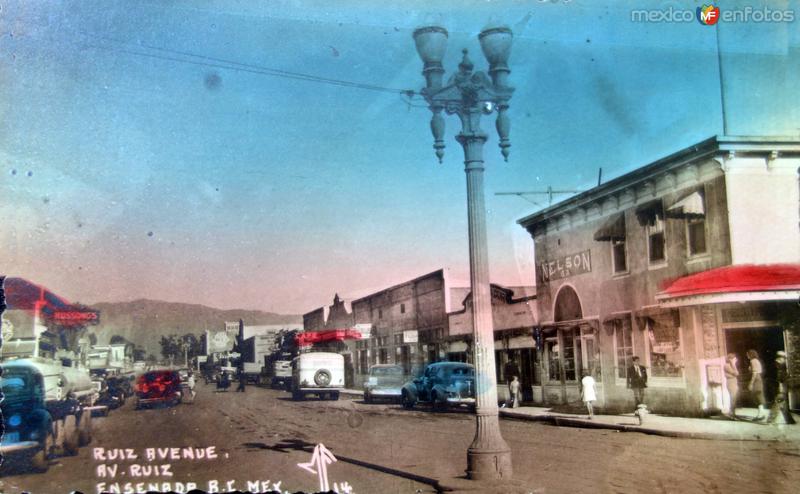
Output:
(725, 326), (784, 407)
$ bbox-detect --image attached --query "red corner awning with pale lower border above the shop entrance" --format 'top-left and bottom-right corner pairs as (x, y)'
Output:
(656, 264), (800, 307)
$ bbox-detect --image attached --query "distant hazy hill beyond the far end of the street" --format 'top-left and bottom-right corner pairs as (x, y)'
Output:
(89, 299), (303, 357)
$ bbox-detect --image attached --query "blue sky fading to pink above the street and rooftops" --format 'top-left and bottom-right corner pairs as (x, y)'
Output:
(0, 0), (800, 313)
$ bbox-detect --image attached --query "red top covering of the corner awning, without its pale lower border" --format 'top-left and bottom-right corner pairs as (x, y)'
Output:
(656, 264), (800, 300)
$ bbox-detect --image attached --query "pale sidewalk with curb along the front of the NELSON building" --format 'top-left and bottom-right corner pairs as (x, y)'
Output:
(342, 389), (800, 441)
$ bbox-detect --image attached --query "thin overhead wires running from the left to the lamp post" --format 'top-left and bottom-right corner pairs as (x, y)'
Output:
(80, 31), (416, 95)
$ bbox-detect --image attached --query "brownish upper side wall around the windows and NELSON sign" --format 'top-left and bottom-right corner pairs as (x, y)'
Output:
(534, 160), (731, 321)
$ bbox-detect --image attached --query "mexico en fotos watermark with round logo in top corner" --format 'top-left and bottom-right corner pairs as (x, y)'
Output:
(631, 5), (795, 26)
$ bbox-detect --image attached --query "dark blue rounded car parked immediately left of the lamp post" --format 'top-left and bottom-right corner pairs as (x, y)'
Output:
(401, 362), (475, 410)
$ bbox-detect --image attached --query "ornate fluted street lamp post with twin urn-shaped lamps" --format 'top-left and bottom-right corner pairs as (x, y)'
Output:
(414, 26), (514, 480)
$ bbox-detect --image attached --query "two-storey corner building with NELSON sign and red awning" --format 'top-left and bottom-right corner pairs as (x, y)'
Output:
(519, 138), (800, 414)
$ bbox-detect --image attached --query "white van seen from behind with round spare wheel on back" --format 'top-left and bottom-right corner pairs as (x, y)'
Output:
(291, 352), (344, 400)
